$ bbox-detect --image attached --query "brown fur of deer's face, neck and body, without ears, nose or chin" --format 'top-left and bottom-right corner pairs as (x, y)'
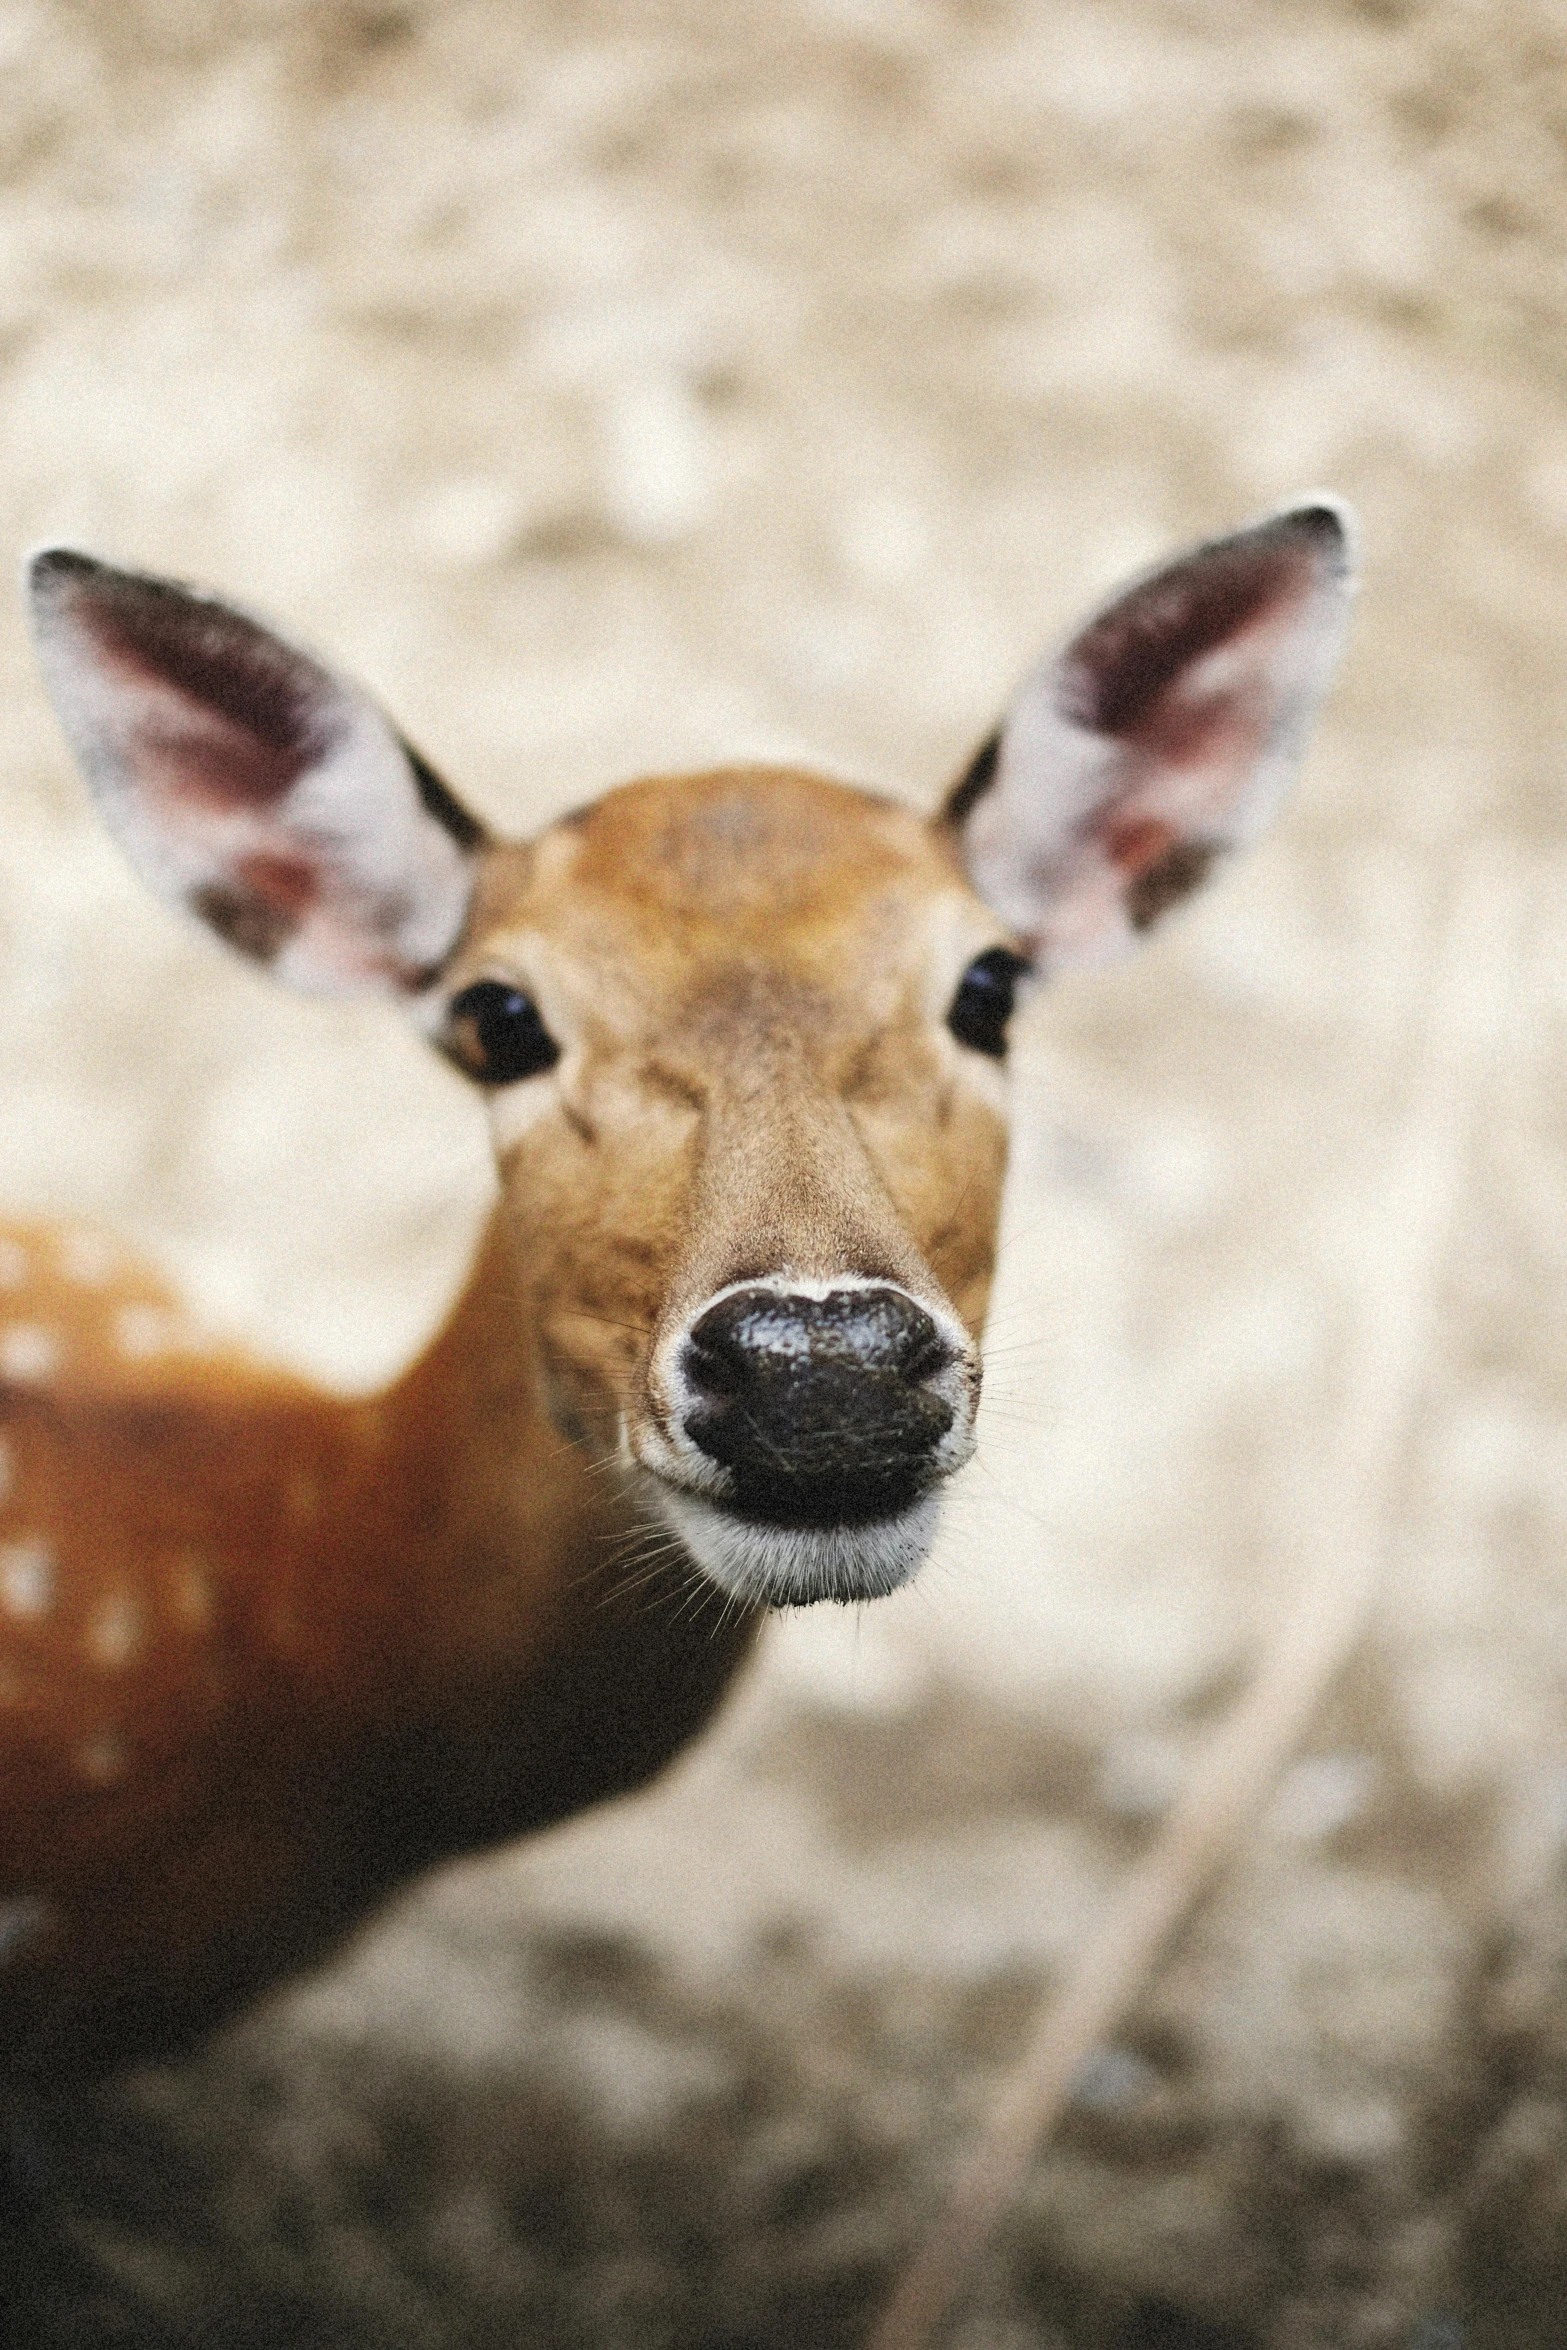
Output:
(0, 771), (1006, 2073)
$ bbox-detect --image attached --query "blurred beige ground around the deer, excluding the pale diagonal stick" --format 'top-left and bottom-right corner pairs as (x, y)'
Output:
(0, 0), (1567, 2350)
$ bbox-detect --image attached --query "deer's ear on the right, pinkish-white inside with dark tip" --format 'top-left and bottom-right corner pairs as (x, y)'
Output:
(940, 498), (1353, 971)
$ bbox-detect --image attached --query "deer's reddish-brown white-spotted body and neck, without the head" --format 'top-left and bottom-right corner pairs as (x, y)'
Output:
(0, 1229), (754, 2077)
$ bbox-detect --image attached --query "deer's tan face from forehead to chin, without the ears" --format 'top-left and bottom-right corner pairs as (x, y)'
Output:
(435, 771), (1008, 1593)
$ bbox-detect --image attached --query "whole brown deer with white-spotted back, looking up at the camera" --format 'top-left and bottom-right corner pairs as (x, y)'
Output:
(0, 496), (1353, 2094)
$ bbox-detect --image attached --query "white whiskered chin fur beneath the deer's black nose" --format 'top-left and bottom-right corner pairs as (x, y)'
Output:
(653, 1478), (942, 1607)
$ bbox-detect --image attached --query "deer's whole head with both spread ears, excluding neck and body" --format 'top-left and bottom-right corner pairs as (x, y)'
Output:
(33, 503), (1349, 1605)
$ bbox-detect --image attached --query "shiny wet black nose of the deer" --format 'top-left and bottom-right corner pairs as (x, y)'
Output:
(681, 1288), (956, 1525)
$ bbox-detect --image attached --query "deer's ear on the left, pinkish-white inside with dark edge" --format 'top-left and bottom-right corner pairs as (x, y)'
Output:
(28, 548), (484, 996)
